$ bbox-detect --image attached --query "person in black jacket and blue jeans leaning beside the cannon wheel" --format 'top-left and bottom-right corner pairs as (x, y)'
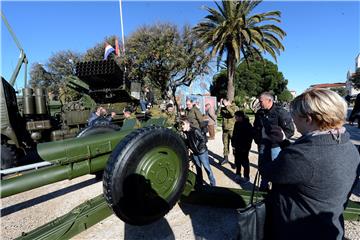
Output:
(180, 117), (216, 186)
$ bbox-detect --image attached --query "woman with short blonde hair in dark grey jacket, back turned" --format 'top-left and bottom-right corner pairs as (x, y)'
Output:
(259, 89), (360, 239)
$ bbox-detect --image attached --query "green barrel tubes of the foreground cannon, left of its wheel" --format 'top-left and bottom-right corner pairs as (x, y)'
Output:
(0, 130), (132, 198)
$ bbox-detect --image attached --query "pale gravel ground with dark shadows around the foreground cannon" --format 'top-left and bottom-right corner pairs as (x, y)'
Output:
(0, 126), (360, 240)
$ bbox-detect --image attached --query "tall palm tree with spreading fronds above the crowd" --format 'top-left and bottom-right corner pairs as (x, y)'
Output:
(194, 0), (286, 100)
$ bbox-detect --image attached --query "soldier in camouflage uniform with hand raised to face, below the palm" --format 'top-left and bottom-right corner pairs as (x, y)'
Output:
(220, 99), (238, 165)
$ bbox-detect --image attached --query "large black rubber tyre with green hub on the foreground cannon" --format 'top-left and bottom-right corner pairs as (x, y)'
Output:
(103, 126), (189, 225)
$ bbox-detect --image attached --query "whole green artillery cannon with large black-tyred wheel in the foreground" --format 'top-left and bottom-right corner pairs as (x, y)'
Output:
(1, 123), (360, 239)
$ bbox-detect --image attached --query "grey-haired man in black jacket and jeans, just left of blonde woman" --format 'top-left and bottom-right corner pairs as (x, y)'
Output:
(254, 92), (295, 191)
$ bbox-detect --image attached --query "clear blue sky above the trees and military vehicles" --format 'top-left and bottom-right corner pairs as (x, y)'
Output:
(1, 1), (360, 93)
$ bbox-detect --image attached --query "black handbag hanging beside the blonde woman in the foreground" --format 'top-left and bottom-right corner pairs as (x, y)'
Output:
(237, 172), (266, 240)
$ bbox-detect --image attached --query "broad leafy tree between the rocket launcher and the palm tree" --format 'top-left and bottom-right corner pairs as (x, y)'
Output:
(126, 23), (210, 105)
